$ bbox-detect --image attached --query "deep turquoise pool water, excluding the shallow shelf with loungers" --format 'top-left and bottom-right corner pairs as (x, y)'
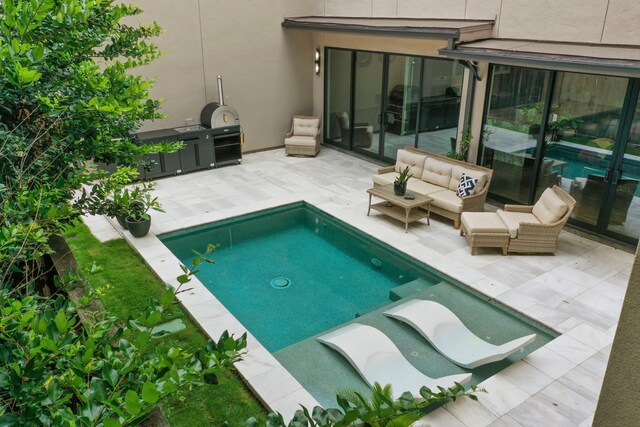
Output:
(161, 204), (440, 352)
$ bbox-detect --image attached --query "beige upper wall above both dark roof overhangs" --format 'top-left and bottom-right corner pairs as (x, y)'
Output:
(313, 0), (640, 45)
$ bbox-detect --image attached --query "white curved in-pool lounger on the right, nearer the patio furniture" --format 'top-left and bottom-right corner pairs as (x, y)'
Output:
(384, 299), (536, 369)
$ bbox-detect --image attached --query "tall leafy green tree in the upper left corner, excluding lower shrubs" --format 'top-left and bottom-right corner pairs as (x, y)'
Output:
(0, 0), (176, 286)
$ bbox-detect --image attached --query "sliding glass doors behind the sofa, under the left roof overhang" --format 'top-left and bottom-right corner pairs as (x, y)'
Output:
(325, 48), (463, 162)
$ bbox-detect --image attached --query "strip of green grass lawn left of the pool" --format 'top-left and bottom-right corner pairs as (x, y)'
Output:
(65, 224), (266, 427)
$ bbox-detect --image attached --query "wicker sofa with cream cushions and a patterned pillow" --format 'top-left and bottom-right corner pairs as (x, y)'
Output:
(373, 147), (493, 229)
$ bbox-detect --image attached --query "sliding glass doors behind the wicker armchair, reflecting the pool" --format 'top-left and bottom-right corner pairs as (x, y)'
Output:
(480, 65), (640, 242)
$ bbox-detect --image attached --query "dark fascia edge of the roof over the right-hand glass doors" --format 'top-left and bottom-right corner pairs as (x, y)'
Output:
(438, 46), (640, 77)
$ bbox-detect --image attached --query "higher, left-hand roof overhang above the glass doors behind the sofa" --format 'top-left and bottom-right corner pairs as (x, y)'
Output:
(282, 16), (493, 42)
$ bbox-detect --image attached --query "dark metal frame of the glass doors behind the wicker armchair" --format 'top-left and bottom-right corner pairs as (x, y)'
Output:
(476, 63), (640, 245)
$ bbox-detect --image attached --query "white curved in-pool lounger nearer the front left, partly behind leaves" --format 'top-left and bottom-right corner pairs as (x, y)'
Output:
(317, 323), (471, 398)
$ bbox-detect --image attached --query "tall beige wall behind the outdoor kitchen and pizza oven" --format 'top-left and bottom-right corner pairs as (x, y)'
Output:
(133, 0), (315, 151)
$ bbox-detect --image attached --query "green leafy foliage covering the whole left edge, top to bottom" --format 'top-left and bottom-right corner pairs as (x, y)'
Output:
(0, 0), (246, 426)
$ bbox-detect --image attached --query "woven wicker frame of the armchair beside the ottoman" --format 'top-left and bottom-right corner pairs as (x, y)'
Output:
(498, 185), (576, 253)
